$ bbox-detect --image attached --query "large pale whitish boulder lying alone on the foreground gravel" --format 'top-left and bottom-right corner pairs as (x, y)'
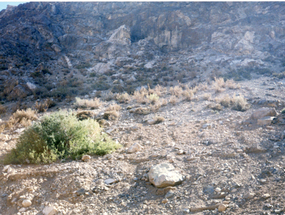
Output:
(148, 163), (184, 188)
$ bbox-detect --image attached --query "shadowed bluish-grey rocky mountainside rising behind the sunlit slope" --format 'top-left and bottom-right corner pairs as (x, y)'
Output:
(0, 2), (285, 100)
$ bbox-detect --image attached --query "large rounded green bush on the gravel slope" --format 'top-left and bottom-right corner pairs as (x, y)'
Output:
(4, 111), (120, 163)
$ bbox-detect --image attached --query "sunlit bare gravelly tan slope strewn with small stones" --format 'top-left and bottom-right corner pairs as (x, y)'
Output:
(0, 77), (285, 215)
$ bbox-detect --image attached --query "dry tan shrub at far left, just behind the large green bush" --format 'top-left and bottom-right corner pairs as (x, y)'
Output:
(6, 108), (38, 128)
